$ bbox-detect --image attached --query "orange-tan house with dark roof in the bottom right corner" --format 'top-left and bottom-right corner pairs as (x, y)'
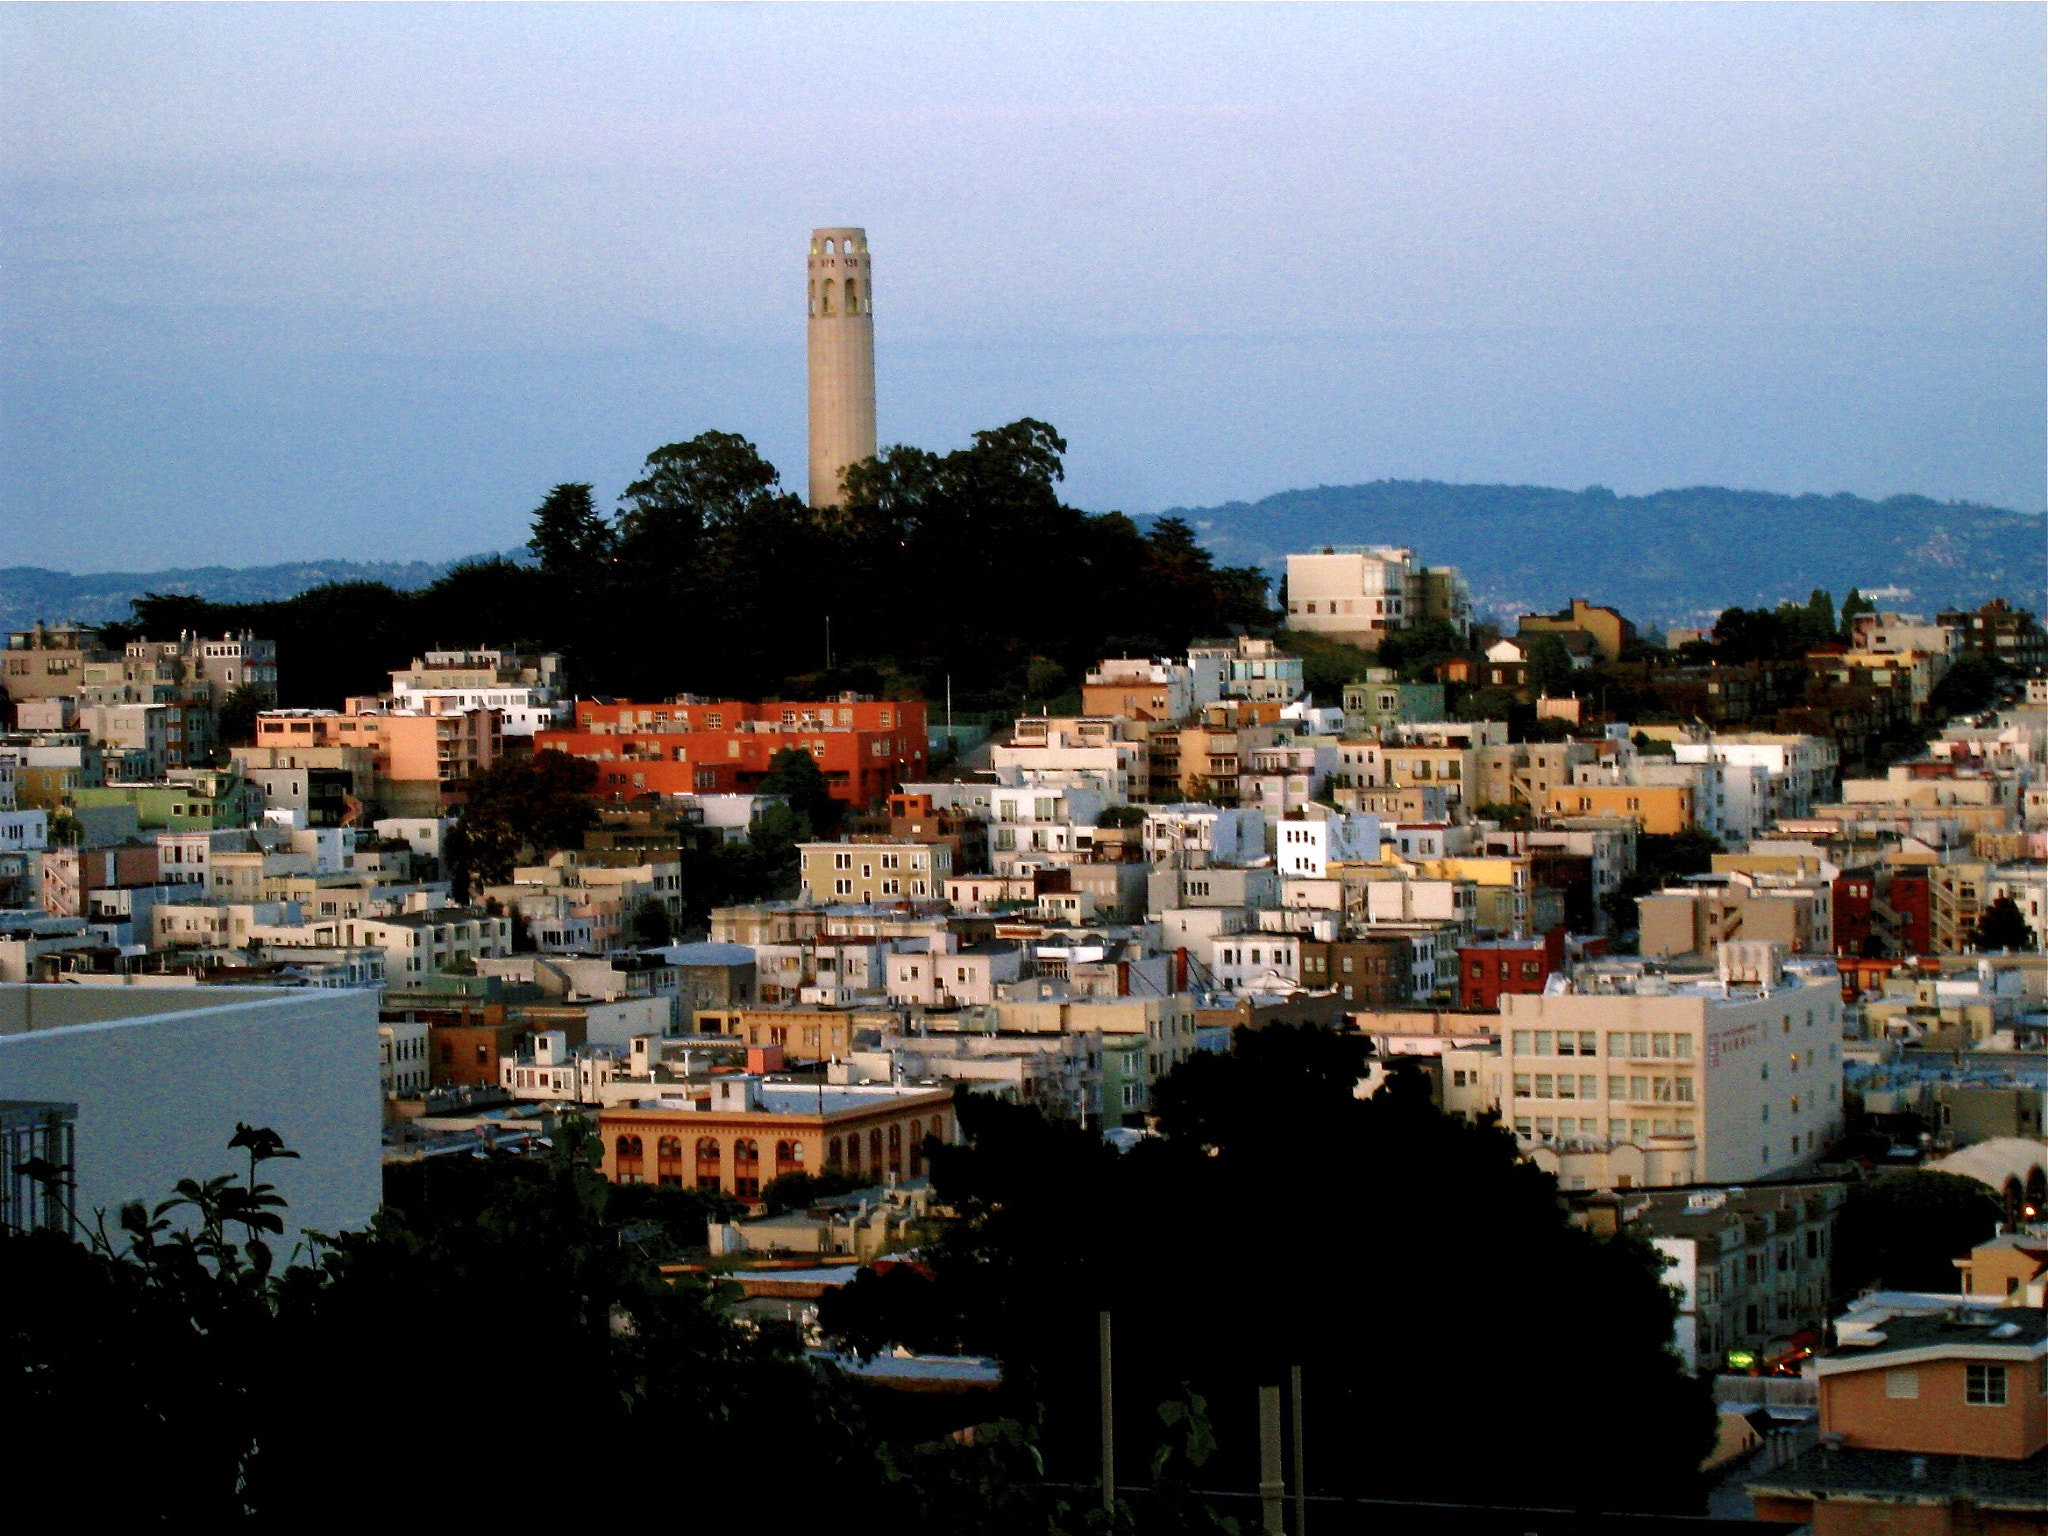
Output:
(1749, 1305), (2048, 1536)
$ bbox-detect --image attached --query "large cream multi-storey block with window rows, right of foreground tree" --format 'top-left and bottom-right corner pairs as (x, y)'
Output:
(1501, 944), (1841, 1190)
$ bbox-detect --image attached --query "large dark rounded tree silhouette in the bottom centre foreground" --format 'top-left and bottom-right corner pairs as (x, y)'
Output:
(821, 1026), (1714, 1507)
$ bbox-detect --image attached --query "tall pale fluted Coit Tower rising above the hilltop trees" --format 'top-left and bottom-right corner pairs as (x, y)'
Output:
(809, 229), (874, 506)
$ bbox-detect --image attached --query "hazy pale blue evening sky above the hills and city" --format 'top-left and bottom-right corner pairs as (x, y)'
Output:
(0, 4), (2048, 569)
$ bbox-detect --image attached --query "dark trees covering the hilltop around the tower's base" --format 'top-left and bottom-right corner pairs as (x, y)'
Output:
(117, 418), (1276, 709)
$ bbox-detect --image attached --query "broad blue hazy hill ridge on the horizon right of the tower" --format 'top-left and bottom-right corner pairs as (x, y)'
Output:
(1159, 479), (2048, 625)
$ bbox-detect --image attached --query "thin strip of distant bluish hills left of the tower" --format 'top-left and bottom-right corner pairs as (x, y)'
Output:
(0, 549), (530, 629)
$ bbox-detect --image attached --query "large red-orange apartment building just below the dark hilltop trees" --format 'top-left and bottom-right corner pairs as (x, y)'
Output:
(535, 696), (926, 807)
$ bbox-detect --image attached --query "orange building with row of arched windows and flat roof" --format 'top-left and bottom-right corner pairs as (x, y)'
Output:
(598, 1077), (954, 1200)
